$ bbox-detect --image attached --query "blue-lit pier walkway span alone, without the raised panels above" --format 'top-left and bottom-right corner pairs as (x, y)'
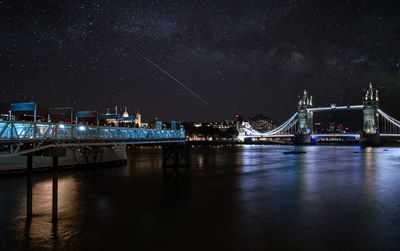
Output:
(0, 121), (185, 154)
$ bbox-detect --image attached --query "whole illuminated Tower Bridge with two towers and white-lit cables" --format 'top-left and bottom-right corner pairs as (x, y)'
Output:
(238, 83), (400, 145)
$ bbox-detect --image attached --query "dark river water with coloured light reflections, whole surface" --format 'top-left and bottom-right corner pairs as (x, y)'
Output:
(0, 145), (400, 250)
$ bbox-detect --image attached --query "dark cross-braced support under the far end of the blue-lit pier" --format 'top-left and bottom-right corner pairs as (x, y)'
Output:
(163, 144), (190, 180)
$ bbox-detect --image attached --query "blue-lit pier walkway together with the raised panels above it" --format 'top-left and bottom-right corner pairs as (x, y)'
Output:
(0, 103), (185, 157)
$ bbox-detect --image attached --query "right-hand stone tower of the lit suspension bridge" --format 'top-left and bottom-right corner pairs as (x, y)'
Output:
(360, 83), (381, 145)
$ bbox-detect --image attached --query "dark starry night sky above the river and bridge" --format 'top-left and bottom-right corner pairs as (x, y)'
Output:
(0, 0), (400, 121)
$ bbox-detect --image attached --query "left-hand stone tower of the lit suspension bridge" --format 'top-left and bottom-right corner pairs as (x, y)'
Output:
(294, 90), (313, 144)
